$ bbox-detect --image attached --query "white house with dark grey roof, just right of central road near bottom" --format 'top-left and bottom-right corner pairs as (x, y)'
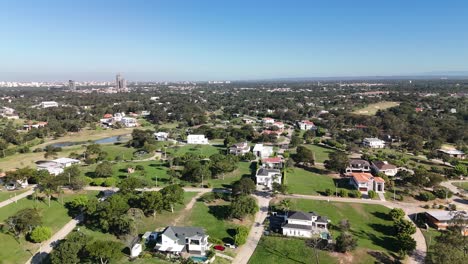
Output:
(282, 211), (329, 237)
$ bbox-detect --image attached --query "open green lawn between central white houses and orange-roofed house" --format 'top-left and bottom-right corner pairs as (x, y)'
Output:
(285, 168), (348, 195)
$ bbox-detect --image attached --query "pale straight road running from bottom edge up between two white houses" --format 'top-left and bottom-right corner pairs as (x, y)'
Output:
(232, 192), (271, 264)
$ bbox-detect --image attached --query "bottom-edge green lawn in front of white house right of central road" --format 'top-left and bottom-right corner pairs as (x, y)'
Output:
(249, 236), (338, 264)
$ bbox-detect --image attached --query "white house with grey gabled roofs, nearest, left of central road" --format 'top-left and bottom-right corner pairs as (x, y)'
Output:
(154, 226), (210, 256)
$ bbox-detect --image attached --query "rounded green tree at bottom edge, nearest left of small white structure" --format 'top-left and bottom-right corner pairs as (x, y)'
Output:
(86, 240), (122, 264)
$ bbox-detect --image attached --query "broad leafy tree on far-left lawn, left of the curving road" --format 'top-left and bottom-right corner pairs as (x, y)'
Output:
(5, 208), (42, 237)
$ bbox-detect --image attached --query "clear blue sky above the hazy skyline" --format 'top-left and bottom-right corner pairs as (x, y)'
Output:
(0, 0), (468, 80)
